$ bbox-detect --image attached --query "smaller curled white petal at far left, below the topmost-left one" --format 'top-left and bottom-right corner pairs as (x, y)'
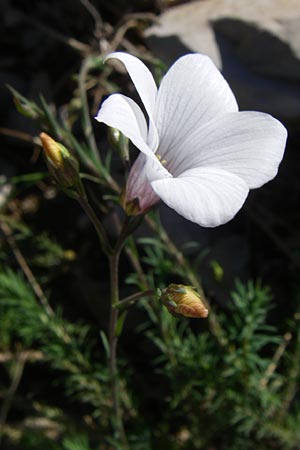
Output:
(95, 94), (157, 160)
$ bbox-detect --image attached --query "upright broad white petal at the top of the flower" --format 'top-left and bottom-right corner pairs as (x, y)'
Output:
(155, 53), (238, 156)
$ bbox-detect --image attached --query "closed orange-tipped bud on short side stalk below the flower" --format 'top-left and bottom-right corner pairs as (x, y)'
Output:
(160, 284), (208, 318)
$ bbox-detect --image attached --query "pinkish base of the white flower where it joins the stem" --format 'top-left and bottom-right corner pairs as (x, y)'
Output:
(122, 154), (160, 216)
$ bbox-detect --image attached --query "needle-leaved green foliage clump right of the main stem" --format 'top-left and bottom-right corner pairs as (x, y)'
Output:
(133, 283), (299, 449)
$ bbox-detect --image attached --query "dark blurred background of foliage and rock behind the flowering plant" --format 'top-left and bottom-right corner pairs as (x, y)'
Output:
(0, 0), (300, 450)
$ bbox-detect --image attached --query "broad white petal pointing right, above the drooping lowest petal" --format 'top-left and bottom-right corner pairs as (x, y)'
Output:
(164, 112), (287, 189)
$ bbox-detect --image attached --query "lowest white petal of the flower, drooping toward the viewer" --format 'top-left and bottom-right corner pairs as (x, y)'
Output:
(151, 167), (249, 227)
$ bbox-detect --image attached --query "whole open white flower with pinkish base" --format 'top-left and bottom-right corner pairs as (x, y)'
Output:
(96, 52), (287, 227)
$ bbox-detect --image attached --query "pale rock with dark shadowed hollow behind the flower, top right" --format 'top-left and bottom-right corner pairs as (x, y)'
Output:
(146, 0), (300, 120)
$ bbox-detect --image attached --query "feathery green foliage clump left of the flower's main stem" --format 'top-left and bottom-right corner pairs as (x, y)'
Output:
(0, 269), (110, 448)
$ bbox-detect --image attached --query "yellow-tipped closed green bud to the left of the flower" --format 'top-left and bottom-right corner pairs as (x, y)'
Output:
(40, 133), (84, 198)
